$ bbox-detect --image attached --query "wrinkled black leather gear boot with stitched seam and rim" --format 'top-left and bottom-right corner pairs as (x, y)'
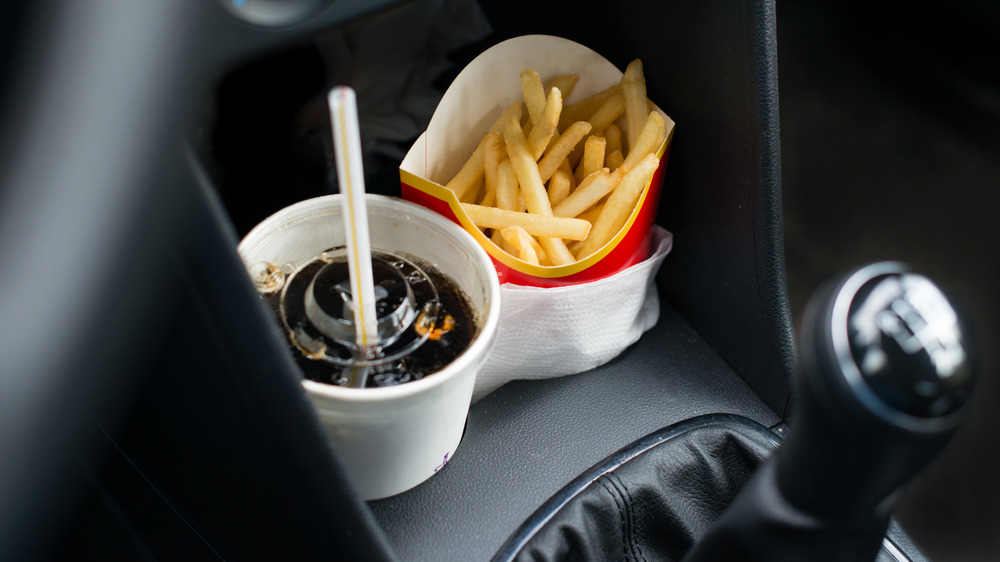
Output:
(494, 415), (778, 562)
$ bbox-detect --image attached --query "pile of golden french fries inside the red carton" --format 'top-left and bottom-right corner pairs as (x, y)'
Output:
(446, 59), (673, 266)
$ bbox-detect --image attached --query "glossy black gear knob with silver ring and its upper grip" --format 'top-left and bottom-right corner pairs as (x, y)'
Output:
(776, 263), (975, 516)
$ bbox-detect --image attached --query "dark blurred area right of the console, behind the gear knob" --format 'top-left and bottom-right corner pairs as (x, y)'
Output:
(777, 0), (1000, 560)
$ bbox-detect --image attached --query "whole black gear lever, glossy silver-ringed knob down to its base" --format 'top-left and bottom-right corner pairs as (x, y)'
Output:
(684, 263), (975, 562)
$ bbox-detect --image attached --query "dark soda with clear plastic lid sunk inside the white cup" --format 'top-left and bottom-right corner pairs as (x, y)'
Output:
(261, 248), (478, 388)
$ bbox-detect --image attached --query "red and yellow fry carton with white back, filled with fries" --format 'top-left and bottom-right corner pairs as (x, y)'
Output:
(399, 35), (674, 287)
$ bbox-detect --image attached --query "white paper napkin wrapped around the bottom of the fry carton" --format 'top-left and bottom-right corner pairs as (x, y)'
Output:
(472, 226), (673, 402)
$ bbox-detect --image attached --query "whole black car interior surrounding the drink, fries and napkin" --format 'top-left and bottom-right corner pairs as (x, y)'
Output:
(0, 0), (1000, 562)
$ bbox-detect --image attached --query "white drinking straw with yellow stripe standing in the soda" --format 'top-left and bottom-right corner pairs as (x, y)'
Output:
(327, 86), (379, 349)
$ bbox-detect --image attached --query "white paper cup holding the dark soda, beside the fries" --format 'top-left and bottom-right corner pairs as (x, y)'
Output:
(238, 195), (500, 499)
